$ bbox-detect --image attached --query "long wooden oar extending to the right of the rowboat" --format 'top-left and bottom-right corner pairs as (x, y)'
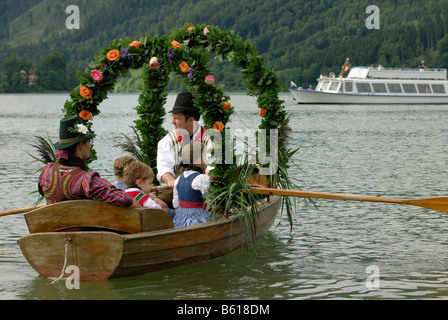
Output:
(253, 187), (448, 212)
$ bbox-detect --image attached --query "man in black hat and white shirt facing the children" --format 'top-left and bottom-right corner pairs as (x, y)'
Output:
(157, 91), (210, 208)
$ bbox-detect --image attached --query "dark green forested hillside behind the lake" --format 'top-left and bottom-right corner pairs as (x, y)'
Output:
(0, 0), (448, 92)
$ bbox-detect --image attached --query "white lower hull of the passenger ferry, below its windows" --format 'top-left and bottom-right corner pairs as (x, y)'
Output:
(289, 89), (448, 104)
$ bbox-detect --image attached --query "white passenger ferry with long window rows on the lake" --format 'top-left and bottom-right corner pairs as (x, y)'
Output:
(290, 59), (448, 104)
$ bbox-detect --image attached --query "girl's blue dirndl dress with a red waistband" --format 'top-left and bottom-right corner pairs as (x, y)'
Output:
(173, 172), (214, 228)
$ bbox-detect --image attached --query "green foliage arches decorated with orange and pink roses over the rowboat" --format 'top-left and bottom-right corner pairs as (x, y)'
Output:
(64, 24), (295, 216)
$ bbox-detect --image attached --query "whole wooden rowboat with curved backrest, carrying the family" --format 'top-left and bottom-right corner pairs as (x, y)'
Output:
(18, 196), (282, 280)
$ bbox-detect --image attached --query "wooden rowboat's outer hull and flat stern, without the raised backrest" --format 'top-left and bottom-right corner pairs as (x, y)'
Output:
(18, 196), (281, 280)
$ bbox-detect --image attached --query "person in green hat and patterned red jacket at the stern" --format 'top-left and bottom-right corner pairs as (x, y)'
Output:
(39, 115), (141, 208)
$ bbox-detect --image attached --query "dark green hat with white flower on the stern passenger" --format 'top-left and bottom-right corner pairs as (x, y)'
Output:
(54, 115), (95, 150)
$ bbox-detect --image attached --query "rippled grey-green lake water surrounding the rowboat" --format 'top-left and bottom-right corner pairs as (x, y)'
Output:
(0, 93), (448, 300)
